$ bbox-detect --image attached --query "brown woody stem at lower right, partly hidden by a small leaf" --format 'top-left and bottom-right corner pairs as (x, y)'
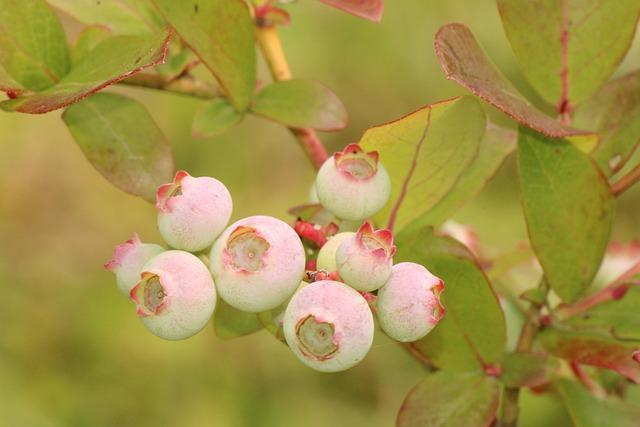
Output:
(498, 277), (549, 427)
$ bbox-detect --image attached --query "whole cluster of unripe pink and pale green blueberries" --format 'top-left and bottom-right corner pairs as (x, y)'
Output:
(105, 144), (444, 372)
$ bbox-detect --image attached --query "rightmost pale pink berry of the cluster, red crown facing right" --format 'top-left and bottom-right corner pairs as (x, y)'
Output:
(377, 262), (444, 342)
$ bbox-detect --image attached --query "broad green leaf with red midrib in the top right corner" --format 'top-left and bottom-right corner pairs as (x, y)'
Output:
(498, 0), (640, 107)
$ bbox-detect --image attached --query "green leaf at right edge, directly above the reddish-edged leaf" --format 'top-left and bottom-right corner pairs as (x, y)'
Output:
(567, 286), (640, 342)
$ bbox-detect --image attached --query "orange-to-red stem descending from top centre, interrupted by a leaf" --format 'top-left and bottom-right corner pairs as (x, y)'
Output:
(256, 22), (328, 169)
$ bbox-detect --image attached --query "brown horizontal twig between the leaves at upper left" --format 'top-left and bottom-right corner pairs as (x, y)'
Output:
(119, 72), (224, 99)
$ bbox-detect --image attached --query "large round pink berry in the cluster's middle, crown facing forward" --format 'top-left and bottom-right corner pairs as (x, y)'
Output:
(209, 216), (305, 312)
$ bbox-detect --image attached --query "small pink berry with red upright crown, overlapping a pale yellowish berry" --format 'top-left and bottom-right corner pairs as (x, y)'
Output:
(336, 222), (396, 292)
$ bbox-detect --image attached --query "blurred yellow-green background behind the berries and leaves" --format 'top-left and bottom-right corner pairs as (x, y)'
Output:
(0, 0), (640, 427)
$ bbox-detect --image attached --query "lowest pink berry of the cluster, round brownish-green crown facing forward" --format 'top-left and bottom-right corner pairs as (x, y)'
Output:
(283, 280), (374, 372)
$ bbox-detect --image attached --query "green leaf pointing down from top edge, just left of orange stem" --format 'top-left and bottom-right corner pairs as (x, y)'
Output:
(153, 0), (256, 111)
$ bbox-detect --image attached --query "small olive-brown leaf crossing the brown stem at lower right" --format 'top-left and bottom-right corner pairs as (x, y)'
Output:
(500, 353), (560, 388)
